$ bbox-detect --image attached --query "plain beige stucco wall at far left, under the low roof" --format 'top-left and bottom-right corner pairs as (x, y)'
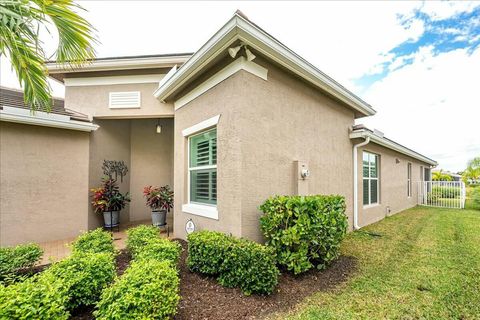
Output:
(0, 122), (89, 246)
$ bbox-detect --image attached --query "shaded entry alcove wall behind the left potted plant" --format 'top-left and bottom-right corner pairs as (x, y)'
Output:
(87, 119), (131, 229)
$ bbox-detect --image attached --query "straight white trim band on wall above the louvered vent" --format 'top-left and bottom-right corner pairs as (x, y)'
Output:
(64, 74), (165, 87)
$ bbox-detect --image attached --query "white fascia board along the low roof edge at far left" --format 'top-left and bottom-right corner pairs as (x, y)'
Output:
(0, 106), (98, 132)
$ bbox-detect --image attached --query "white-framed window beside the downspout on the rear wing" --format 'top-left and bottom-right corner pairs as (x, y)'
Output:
(363, 152), (379, 206)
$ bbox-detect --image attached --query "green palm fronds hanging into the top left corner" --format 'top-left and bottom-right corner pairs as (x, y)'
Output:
(0, 0), (97, 111)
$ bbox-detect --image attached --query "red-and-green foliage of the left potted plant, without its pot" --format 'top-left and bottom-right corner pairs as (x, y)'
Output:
(91, 178), (130, 214)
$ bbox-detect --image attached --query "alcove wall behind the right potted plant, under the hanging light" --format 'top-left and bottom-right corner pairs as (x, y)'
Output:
(129, 119), (173, 221)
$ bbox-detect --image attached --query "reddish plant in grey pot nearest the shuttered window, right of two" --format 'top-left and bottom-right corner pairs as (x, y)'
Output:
(143, 185), (173, 227)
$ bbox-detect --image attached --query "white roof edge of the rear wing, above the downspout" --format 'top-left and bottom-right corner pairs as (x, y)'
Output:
(350, 124), (438, 166)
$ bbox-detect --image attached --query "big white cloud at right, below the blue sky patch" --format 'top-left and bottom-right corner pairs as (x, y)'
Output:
(360, 47), (480, 171)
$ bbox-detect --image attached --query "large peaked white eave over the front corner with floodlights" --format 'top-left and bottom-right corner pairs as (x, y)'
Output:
(154, 11), (375, 116)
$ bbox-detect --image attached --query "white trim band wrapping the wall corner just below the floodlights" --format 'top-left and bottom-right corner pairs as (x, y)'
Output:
(174, 57), (268, 110)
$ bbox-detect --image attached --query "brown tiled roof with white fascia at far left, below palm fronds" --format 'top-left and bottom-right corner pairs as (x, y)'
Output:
(0, 87), (98, 131)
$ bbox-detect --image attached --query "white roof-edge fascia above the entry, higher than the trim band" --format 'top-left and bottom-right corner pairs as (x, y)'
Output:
(46, 55), (191, 74)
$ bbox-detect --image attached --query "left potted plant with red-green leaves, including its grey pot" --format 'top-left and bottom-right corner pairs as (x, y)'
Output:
(91, 177), (130, 228)
